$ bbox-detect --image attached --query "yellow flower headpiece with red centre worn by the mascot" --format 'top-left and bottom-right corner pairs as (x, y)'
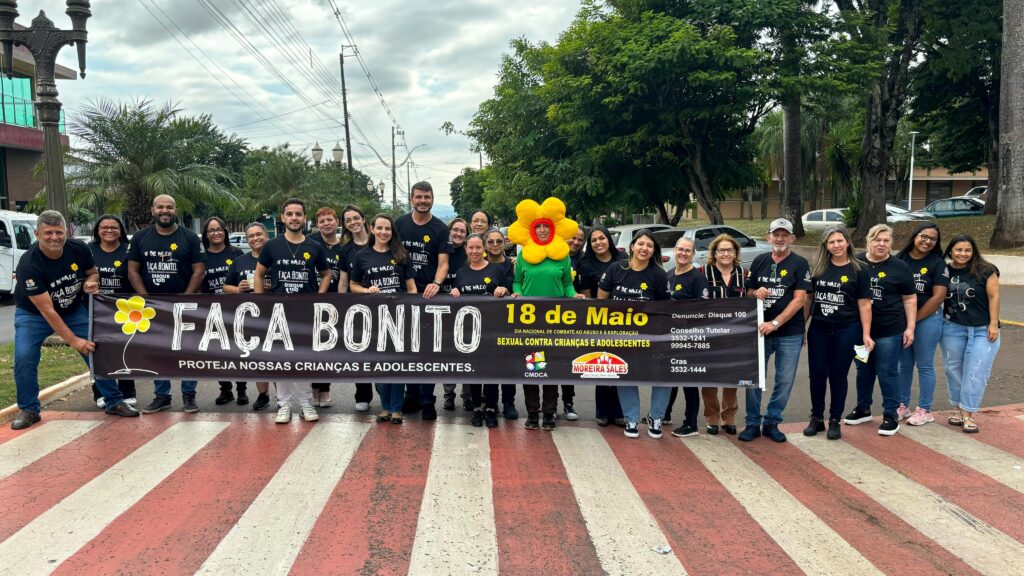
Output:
(508, 198), (580, 264)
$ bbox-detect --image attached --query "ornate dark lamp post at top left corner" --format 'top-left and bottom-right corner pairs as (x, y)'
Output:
(0, 0), (92, 215)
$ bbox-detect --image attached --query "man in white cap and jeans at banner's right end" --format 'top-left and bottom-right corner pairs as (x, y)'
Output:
(738, 218), (812, 442)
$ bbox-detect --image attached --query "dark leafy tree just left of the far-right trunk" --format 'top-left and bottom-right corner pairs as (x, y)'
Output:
(910, 0), (1002, 214)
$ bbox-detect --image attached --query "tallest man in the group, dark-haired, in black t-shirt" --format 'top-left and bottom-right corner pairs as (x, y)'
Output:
(394, 181), (452, 420)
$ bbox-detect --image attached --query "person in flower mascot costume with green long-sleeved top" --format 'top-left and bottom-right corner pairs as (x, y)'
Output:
(508, 198), (582, 430)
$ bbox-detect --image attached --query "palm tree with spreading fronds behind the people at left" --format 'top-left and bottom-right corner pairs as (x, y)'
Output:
(67, 99), (238, 229)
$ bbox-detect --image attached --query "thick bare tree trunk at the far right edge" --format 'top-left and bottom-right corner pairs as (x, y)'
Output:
(989, 0), (1024, 248)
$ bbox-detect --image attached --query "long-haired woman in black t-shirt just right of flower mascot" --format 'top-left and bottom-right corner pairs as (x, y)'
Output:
(573, 224), (626, 426)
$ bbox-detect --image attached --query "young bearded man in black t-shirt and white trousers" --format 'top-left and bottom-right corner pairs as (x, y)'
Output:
(253, 198), (331, 424)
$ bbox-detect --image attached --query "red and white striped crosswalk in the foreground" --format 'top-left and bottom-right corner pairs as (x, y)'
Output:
(0, 405), (1024, 576)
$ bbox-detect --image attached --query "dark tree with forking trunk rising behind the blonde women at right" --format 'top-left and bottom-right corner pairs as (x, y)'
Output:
(835, 0), (925, 241)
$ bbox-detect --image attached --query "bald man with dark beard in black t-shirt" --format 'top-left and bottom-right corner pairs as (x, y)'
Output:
(128, 194), (206, 414)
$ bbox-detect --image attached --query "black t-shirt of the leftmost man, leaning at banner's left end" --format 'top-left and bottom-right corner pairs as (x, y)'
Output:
(14, 239), (96, 317)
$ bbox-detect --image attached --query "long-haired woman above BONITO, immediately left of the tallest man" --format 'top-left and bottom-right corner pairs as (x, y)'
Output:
(349, 214), (416, 424)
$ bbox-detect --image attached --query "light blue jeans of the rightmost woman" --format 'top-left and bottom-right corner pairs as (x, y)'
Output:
(942, 322), (1002, 412)
